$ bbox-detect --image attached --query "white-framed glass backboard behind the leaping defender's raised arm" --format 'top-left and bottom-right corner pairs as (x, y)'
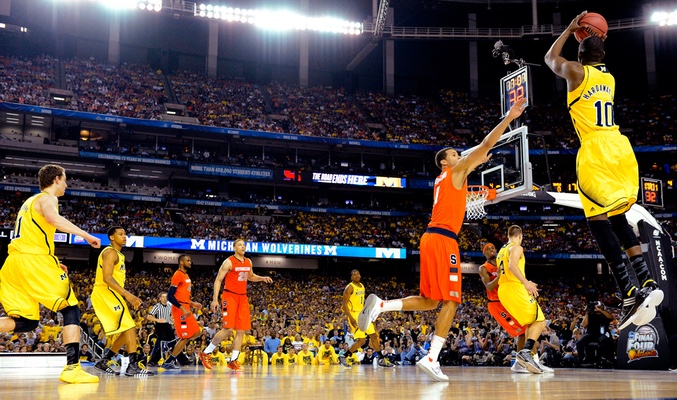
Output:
(461, 126), (533, 204)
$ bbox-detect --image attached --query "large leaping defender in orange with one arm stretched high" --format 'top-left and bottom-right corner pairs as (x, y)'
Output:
(358, 98), (526, 382)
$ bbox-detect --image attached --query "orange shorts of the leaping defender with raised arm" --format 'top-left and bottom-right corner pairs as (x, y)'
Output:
(421, 233), (461, 303)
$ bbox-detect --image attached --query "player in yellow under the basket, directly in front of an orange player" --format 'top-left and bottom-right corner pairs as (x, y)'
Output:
(496, 225), (545, 374)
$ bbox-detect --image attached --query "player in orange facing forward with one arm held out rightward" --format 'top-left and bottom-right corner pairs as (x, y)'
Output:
(200, 239), (273, 371)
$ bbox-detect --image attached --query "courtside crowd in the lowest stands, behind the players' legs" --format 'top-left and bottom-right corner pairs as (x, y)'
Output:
(0, 266), (618, 367)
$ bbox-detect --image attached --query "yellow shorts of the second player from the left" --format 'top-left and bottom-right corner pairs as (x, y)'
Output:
(92, 286), (136, 336)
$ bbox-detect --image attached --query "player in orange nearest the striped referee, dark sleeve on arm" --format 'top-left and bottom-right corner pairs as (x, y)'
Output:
(162, 254), (202, 369)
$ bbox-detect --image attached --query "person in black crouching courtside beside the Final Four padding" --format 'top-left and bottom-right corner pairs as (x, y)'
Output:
(576, 301), (614, 364)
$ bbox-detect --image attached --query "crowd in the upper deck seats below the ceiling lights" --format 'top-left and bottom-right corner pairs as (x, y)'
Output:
(0, 56), (677, 149)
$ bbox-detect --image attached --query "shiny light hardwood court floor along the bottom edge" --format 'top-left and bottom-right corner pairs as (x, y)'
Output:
(0, 366), (677, 400)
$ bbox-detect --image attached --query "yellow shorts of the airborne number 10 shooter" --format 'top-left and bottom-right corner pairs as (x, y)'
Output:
(576, 132), (639, 218)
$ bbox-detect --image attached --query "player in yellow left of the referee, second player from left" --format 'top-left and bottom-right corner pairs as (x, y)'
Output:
(92, 226), (153, 376)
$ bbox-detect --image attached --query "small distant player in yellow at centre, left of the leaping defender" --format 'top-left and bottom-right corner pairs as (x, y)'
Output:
(339, 269), (394, 367)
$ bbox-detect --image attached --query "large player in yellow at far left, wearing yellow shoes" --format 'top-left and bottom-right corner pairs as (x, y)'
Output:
(0, 164), (101, 383)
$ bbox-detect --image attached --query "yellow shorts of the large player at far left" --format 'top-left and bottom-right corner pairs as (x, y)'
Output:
(0, 253), (78, 320)
